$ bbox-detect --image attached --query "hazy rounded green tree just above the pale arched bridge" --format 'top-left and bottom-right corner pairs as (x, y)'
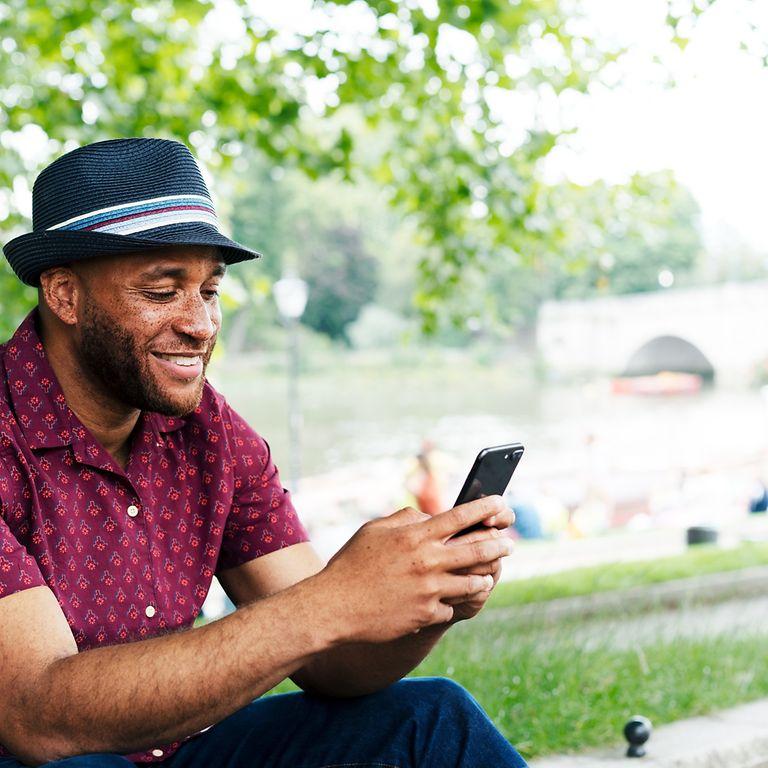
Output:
(476, 172), (702, 327)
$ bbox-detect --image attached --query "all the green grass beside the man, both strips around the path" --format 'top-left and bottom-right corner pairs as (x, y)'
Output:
(266, 543), (768, 758)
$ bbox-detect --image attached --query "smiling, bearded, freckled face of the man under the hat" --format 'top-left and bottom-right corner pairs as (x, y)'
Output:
(73, 247), (224, 416)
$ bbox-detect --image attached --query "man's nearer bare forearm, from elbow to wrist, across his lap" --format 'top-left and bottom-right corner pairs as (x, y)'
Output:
(30, 580), (332, 759)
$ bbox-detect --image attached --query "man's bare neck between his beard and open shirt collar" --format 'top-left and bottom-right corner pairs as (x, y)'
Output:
(39, 314), (141, 469)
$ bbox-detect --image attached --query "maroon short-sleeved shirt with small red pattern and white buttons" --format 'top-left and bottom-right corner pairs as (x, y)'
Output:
(0, 312), (307, 762)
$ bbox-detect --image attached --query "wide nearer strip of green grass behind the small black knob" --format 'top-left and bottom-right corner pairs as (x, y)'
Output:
(414, 620), (768, 757)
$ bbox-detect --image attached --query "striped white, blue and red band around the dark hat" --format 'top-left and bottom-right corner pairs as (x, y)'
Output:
(47, 195), (219, 235)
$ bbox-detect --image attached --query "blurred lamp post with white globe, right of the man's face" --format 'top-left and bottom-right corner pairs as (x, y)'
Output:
(272, 277), (309, 492)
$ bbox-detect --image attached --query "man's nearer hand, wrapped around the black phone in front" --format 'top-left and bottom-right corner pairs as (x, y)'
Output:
(315, 496), (512, 643)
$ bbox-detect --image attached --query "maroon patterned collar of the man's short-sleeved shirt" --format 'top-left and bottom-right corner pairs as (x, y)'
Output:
(0, 309), (185, 455)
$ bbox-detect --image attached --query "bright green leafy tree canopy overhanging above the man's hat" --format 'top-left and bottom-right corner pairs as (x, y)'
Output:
(0, 0), (614, 330)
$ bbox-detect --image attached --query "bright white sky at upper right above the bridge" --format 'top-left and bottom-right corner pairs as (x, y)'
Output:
(552, 0), (768, 252)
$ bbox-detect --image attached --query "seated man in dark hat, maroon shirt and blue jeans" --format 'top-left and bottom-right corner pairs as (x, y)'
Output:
(0, 139), (524, 768)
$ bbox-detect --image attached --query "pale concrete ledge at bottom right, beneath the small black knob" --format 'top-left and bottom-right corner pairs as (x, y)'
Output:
(530, 699), (768, 768)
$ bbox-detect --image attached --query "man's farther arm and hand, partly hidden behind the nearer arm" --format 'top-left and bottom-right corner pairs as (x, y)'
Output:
(219, 500), (512, 696)
